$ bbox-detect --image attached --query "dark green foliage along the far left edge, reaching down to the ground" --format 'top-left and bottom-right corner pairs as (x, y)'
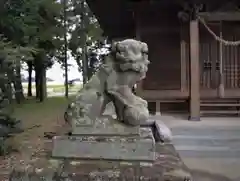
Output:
(0, 38), (35, 155)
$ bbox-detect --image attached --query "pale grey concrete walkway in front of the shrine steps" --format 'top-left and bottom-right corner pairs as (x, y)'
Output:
(153, 115), (240, 181)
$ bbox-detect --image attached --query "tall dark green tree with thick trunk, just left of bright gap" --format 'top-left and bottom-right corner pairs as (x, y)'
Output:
(31, 0), (64, 101)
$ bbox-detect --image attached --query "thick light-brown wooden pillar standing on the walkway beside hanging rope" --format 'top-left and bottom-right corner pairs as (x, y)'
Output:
(189, 19), (200, 121)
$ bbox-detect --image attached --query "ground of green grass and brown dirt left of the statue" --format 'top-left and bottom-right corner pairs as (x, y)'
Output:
(0, 97), (72, 176)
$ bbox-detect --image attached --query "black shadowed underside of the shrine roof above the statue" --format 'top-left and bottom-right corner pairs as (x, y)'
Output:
(87, 0), (236, 38)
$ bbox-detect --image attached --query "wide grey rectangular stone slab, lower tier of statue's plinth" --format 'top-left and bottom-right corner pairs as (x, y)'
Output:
(52, 128), (155, 161)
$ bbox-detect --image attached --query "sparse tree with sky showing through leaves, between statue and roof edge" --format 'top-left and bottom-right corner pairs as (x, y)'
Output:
(69, 0), (104, 83)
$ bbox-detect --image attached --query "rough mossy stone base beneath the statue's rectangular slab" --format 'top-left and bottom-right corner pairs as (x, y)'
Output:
(9, 143), (192, 181)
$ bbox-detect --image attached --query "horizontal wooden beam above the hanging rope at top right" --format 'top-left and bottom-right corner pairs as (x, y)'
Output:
(199, 12), (240, 21)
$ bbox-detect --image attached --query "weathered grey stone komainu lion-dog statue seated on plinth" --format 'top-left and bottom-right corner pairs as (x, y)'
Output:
(65, 39), (149, 126)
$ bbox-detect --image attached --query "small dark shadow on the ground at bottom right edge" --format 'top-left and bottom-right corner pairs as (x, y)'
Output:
(191, 170), (234, 181)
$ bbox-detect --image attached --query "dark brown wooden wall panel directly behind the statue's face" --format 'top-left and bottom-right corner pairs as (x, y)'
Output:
(141, 21), (181, 90)
